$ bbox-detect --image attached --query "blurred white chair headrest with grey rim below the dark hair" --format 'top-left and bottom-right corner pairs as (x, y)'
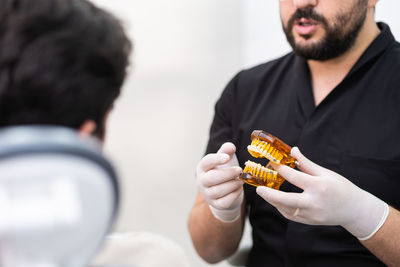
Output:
(0, 126), (119, 267)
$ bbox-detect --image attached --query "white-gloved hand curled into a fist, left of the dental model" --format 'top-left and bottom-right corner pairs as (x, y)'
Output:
(196, 143), (243, 222)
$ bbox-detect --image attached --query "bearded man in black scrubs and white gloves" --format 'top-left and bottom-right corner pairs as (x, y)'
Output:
(188, 0), (400, 267)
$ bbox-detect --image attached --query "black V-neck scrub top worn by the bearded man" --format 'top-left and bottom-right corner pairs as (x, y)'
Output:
(206, 23), (400, 267)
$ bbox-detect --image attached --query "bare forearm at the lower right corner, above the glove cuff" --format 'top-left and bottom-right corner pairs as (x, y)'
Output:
(361, 207), (400, 267)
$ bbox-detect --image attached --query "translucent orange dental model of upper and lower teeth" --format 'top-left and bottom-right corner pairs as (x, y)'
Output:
(239, 130), (298, 189)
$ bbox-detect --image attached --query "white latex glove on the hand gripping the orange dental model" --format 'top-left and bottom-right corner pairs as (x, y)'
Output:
(257, 147), (389, 240)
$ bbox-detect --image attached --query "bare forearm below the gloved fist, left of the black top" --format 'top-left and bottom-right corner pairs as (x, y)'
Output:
(188, 196), (245, 263)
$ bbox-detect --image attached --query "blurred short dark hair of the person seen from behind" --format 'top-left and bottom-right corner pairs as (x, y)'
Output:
(0, 0), (131, 138)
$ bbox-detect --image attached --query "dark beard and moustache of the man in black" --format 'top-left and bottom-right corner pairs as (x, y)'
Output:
(283, 3), (367, 61)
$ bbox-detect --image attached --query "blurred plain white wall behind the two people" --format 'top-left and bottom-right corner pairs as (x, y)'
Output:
(93, 0), (400, 267)
